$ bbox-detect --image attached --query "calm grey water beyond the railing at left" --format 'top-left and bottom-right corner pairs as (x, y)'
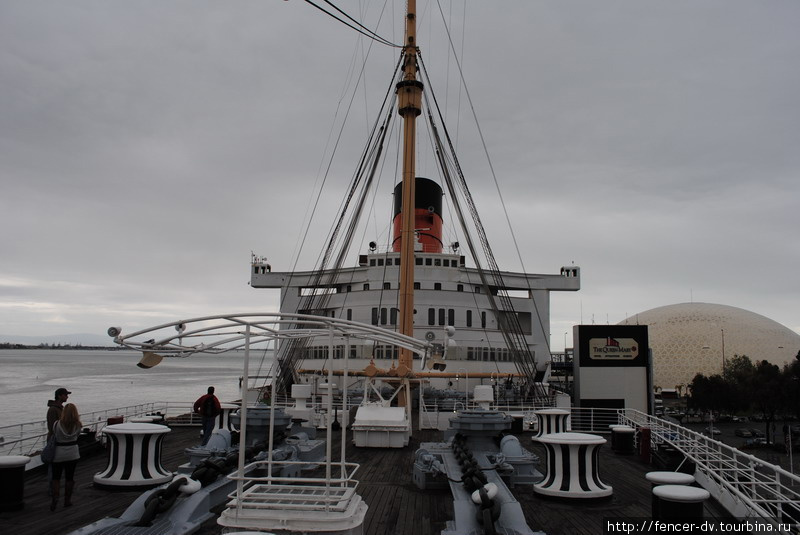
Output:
(0, 349), (270, 426)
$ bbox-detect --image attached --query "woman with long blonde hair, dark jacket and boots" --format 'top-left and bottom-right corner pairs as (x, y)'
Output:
(50, 403), (83, 511)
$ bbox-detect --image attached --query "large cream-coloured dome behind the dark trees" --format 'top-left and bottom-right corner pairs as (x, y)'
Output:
(620, 303), (800, 388)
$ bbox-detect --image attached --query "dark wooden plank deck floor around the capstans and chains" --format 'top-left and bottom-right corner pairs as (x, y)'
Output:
(0, 427), (727, 535)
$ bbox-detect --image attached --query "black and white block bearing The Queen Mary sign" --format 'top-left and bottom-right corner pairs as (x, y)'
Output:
(573, 325), (653, 413)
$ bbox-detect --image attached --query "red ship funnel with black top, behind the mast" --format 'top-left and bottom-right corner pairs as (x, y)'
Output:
(392, 177), (442, 253)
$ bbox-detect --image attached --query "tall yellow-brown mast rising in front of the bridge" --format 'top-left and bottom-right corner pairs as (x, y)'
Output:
(396, 0), (423, 377)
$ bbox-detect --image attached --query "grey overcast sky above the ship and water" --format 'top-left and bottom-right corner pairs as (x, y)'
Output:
(0, 0), (800, 350)
